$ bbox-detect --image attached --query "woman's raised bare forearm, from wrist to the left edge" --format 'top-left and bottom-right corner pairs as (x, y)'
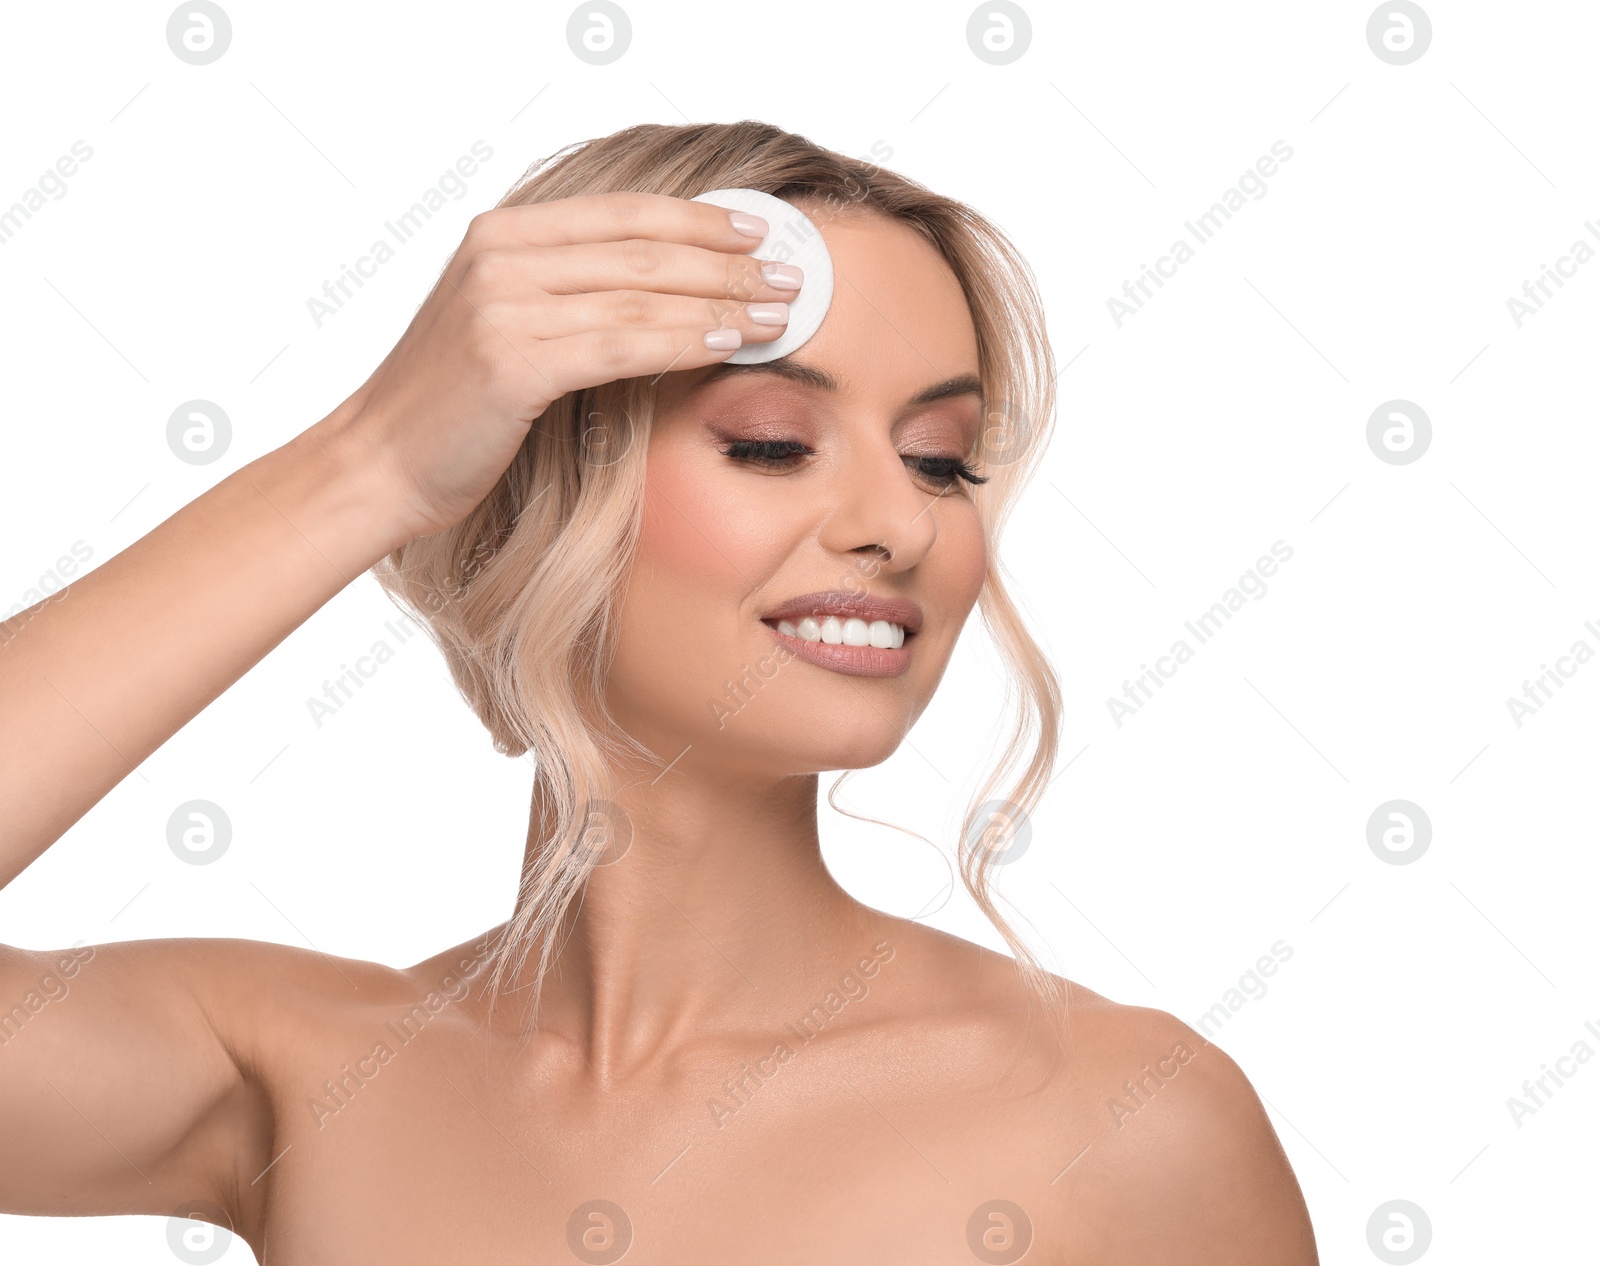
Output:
(0, 415), (406, 887)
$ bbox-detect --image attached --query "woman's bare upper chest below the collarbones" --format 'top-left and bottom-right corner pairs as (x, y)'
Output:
(252, 1044), (1075, 1266)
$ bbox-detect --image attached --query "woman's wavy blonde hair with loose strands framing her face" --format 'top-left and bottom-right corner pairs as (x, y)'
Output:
(374, 120), (1066, 1032)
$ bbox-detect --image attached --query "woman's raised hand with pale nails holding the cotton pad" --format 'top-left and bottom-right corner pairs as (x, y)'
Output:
(320, 192), (800, 539)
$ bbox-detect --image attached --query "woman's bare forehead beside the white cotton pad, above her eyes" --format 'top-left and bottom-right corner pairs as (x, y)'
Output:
(662, 212), (978, 403)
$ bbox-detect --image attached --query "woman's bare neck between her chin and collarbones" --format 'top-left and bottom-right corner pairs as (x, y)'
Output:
(505, 761), (877, 1082)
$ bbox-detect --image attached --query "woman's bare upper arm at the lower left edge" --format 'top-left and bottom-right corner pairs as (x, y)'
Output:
(0, 939), (272, 1218)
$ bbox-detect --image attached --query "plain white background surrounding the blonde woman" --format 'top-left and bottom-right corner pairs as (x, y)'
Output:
(0, 0), (1600, 1263)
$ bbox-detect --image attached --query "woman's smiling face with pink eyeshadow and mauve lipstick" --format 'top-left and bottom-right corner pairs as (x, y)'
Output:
(606, 214), (987, 776)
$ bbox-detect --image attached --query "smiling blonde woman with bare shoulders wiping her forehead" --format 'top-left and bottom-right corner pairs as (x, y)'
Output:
(0, 122), (1317, 1266)
